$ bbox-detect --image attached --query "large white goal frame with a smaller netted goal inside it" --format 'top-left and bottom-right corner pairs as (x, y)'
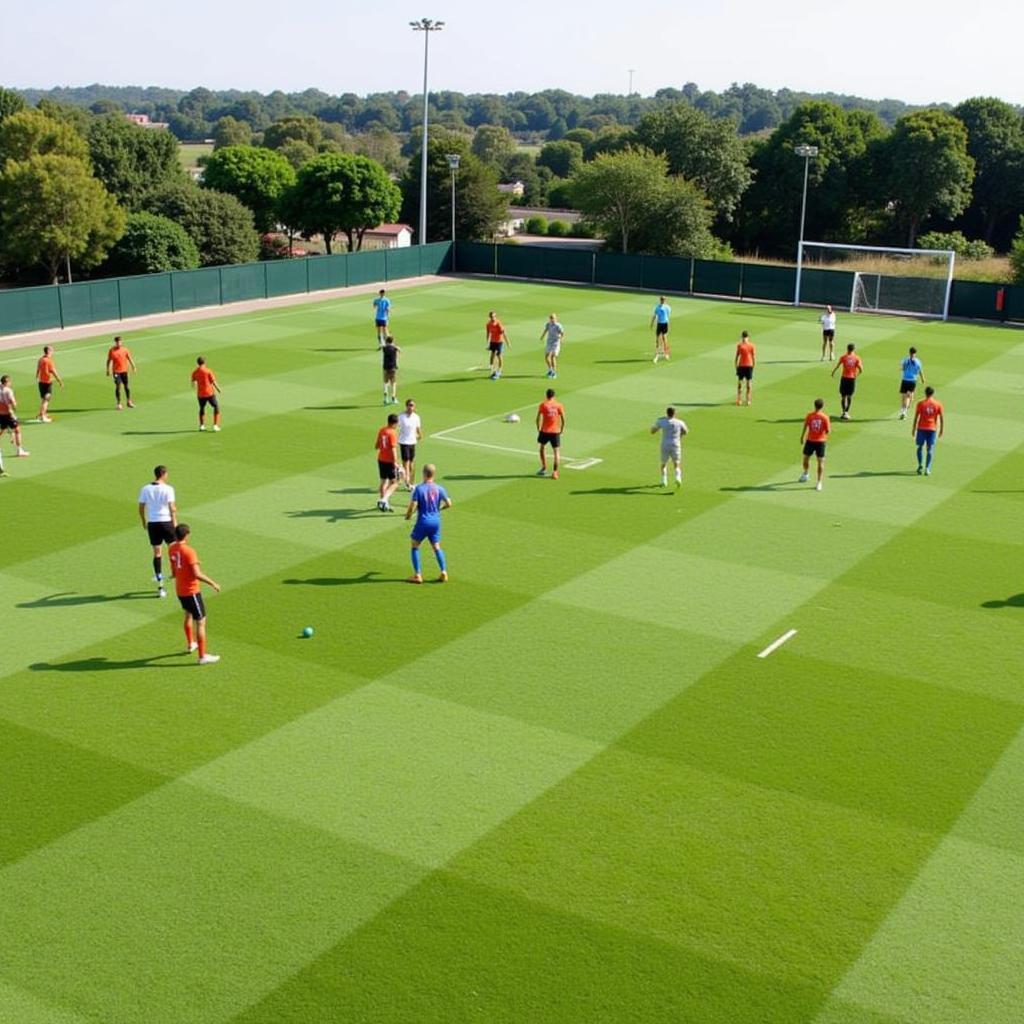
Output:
(793, 242), (956, 319)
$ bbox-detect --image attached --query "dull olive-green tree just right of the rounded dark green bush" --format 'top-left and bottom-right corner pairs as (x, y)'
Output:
(144, 181), (259, 266)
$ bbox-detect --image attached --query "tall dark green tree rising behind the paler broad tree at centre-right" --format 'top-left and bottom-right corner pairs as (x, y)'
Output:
(634, 103), (752, 220)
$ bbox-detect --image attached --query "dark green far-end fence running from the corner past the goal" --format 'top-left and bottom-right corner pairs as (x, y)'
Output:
(455, 242), (1024, 323)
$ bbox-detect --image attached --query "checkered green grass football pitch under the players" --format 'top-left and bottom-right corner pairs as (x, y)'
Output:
(0, 280), (1024, 1024)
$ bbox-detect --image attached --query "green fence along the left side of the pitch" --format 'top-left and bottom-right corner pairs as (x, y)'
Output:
(0, 242), (452, 335)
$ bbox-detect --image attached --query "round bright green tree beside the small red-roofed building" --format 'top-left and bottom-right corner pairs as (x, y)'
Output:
(288, 153), (401, 253)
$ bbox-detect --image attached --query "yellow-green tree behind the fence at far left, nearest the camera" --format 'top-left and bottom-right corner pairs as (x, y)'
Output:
(0, 151), (125, 284)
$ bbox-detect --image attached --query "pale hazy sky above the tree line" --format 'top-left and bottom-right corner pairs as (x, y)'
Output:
(9, 0), (1024, 104)
